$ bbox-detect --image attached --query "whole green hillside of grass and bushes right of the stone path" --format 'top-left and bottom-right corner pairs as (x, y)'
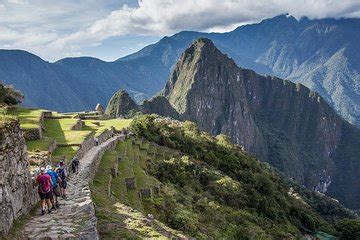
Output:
(91, 115), (358, 239)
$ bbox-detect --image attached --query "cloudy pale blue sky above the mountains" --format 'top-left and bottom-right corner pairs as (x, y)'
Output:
(0, 0), (360, 62)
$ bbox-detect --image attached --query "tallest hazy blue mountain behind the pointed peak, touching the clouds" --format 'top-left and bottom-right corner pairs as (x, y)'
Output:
(118, 15), (360, 126)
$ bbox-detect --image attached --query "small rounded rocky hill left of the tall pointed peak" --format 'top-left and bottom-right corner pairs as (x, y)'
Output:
(105, 90), (138, 118)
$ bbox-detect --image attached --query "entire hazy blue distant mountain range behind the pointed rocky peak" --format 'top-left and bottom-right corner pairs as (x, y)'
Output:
(0, 15), (360, 126)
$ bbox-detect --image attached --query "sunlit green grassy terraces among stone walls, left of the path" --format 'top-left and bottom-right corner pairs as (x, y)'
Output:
(0, 107), (131, 165)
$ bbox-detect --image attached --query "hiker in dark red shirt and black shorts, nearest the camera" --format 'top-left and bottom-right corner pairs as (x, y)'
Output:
(36, 167), (52, 215)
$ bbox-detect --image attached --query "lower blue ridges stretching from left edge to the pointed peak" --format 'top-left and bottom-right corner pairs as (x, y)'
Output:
(0, 50), (168, 111)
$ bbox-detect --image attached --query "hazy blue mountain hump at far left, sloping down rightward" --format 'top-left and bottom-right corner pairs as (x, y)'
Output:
(0, 50), (86, 109)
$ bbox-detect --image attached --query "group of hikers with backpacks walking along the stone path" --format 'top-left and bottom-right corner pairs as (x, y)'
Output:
(36, 157), (79, 215)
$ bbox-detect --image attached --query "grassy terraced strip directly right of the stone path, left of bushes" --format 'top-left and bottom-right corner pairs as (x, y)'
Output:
(91, 139), (181, 239)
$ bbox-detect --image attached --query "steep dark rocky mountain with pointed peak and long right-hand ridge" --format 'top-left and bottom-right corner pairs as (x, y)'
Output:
(106, 38), (360, 209)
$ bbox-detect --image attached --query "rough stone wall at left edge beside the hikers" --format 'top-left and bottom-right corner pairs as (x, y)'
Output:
(0, 121), (37, 235)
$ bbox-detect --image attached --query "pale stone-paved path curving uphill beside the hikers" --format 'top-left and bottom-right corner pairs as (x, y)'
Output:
(22, 136), (123, 239)
